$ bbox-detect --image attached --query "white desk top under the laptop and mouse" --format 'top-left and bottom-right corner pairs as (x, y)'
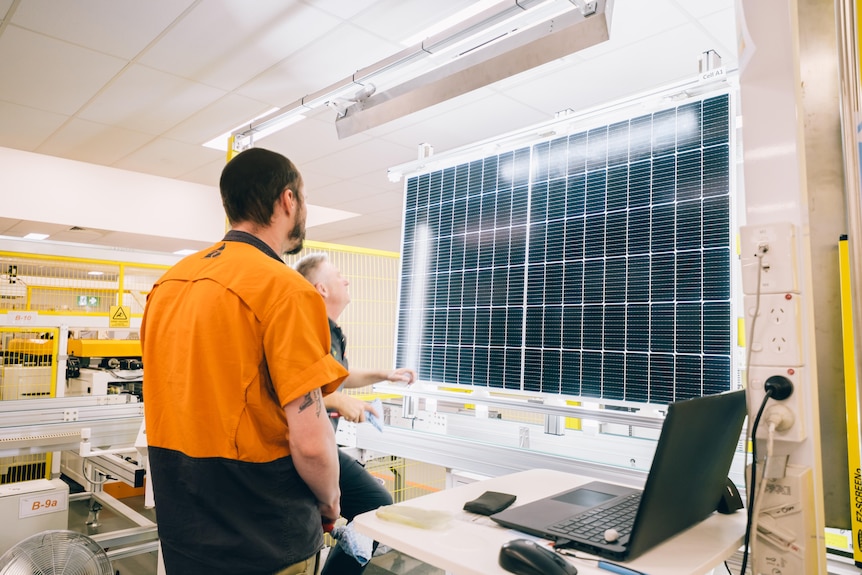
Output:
(354, 469), (745, 575)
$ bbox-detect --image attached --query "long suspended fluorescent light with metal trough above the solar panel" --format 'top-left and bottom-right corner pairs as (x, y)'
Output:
(230, 0), (614, 143)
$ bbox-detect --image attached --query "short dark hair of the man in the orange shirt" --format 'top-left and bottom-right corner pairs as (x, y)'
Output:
(219, 148), (302, 226)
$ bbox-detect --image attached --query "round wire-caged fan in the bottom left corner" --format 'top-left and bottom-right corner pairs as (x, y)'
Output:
(0, 530), (114, 575)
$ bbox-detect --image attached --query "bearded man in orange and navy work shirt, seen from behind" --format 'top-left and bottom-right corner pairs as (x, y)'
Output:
(141, 148), (347, 575)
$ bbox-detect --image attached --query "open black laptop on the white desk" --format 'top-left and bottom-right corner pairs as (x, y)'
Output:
(491, 390), (747, 561)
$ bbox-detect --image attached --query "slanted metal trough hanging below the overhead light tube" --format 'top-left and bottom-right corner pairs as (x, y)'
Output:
(335, 0), (613, 138)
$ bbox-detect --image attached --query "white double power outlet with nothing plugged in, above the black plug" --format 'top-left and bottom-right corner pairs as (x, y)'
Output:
(744, 293), (802, 367)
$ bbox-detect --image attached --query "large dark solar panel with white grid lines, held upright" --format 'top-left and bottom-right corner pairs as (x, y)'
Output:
(396, 95), (732, 403)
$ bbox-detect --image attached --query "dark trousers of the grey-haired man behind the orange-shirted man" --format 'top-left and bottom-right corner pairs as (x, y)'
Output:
(320, 449), (392, 575)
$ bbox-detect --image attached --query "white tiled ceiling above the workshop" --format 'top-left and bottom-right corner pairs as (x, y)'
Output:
(0, 0), (736, 251)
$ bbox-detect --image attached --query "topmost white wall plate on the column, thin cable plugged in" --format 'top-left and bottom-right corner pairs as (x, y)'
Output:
(739, 222), (799, 295)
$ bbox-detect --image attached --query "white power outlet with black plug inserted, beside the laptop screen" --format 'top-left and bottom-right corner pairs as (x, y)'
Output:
(748, 366), (806, 442)
